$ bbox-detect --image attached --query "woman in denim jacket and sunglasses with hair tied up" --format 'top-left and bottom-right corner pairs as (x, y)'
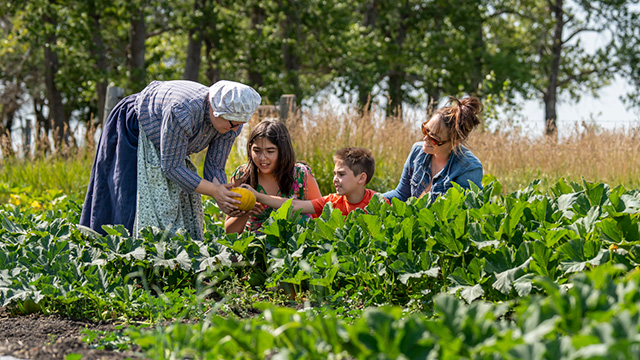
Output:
(384, 97), (483, 202)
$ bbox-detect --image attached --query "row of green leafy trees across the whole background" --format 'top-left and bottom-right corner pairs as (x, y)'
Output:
(0, 0), (640, 152)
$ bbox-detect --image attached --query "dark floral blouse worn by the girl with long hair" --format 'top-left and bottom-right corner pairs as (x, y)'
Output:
(231, 163), (313, 232)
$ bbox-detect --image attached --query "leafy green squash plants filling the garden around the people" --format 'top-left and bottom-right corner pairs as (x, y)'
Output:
(0, 177), (640, 358)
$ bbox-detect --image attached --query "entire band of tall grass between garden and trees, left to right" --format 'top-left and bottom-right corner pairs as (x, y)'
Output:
(0, 109), (640, 199)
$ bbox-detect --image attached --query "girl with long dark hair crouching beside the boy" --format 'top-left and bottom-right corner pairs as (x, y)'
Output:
(224, 120), (322, 233)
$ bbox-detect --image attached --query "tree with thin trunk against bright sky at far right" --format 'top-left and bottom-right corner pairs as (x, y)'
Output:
(505, 0), (637, 135)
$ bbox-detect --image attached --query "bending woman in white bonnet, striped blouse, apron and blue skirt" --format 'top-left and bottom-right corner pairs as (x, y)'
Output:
(80, 80), (261, 240)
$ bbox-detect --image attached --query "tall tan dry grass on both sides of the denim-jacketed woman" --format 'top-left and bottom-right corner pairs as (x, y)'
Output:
(262, 108), (640, 194)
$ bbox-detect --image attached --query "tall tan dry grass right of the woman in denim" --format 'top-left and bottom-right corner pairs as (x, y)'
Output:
(470, 124), (640, 192)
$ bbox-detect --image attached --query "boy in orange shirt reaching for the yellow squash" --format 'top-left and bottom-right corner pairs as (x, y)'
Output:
(245, 147), (384, 216)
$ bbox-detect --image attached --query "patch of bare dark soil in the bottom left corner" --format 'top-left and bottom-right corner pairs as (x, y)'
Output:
(0, 308), (143, 360)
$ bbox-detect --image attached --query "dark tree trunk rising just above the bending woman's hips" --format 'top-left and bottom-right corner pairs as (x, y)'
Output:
(129, 5), (147, 92)
